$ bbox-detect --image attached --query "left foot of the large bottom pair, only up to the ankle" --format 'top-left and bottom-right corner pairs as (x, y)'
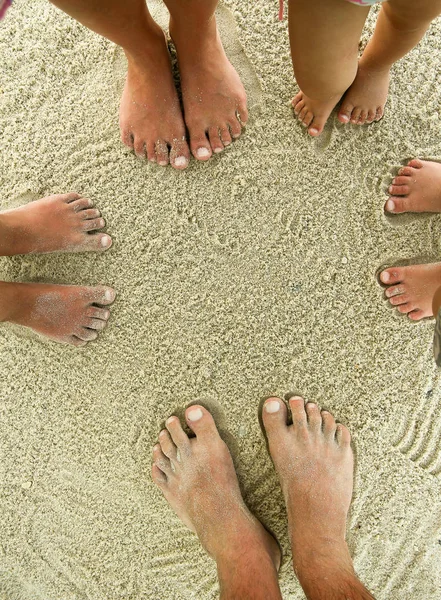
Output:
(152, 405), (280, 568)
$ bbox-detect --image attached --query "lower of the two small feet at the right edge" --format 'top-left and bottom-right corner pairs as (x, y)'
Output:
(380, 263), (441, 321)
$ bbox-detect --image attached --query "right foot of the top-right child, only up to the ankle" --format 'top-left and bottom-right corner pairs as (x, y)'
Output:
(338, 59), (390, 125)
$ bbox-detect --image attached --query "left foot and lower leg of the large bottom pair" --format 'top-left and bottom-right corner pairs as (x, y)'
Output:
(152, 406), (282, 600)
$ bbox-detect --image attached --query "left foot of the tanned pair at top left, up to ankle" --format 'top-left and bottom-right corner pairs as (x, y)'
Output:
(120, 26), (190, 169)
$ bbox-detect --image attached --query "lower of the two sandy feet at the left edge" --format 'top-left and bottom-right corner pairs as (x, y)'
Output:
(0, 282), (115, 346)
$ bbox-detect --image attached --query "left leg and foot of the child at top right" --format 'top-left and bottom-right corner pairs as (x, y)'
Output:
(289, 0), (369, 136)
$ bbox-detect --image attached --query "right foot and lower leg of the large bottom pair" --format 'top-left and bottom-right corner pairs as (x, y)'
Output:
(263, 397), (373, 600)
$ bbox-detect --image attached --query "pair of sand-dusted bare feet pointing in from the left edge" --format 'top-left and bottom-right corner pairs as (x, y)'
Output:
(0, 193), (115, 347)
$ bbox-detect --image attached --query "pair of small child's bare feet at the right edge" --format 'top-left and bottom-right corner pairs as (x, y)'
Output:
(380, 159), (441, 321)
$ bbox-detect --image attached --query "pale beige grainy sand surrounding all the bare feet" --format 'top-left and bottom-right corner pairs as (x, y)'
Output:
(0, 0), (441, 600)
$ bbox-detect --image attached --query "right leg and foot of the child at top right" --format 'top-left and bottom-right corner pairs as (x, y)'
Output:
(338, 0), (441, 125)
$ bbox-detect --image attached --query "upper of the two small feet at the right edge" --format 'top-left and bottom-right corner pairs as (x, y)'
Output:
(384, 158), (441, 214)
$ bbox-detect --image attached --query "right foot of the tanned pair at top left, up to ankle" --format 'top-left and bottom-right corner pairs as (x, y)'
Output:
(170, 17), (248, 161)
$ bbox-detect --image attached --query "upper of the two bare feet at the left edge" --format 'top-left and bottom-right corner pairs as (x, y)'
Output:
(0, 194), (112, 256)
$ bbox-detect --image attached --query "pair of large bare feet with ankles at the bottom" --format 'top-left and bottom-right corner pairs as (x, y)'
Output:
(152, 396), (372, 600)
